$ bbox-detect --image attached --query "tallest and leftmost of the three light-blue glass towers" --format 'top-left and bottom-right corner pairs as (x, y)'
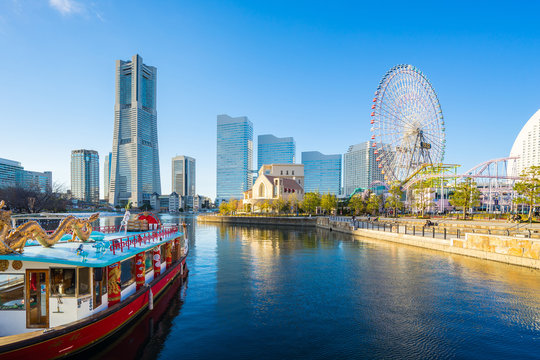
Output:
(216, 115), (253, 202)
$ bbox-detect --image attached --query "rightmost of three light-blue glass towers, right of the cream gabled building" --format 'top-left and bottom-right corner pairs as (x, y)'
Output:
(302, 151), (341, 195)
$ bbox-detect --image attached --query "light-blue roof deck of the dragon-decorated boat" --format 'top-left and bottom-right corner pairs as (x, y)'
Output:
(0, 231), (182, 267)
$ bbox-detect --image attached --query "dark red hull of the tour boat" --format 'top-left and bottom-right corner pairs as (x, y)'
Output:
(0, 257), (187, 359)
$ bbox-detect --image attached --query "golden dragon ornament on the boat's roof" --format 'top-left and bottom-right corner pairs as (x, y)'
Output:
(0, 200), (99, 255)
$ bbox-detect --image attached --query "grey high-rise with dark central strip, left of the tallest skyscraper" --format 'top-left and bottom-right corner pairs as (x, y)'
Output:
(71, 150), (99, 203)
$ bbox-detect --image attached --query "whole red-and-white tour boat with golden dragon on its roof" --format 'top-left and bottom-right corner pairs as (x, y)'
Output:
(0, 208), (188, 359)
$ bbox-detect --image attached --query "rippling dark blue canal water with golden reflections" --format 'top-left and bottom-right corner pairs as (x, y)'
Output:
(88, 217), (540, 359)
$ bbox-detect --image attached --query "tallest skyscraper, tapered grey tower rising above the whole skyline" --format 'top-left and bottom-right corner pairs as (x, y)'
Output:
(109, 55), (161, 206)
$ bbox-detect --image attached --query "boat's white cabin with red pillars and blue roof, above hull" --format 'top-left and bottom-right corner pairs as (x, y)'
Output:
(0, 226), (187, 336)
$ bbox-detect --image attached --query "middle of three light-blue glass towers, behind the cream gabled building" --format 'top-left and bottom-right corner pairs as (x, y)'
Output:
(257, 134), (296, 171)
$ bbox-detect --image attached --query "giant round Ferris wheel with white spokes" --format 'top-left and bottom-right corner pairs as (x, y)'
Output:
(371, 65), (446, 183)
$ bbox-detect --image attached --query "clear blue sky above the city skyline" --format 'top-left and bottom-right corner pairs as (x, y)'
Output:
(0, 0), (540, 197)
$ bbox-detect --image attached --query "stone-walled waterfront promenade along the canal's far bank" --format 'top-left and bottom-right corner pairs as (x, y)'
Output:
(197, 216), (540, 269)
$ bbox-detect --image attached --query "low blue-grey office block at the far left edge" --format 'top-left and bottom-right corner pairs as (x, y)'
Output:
(0, 158), (52, 193)
